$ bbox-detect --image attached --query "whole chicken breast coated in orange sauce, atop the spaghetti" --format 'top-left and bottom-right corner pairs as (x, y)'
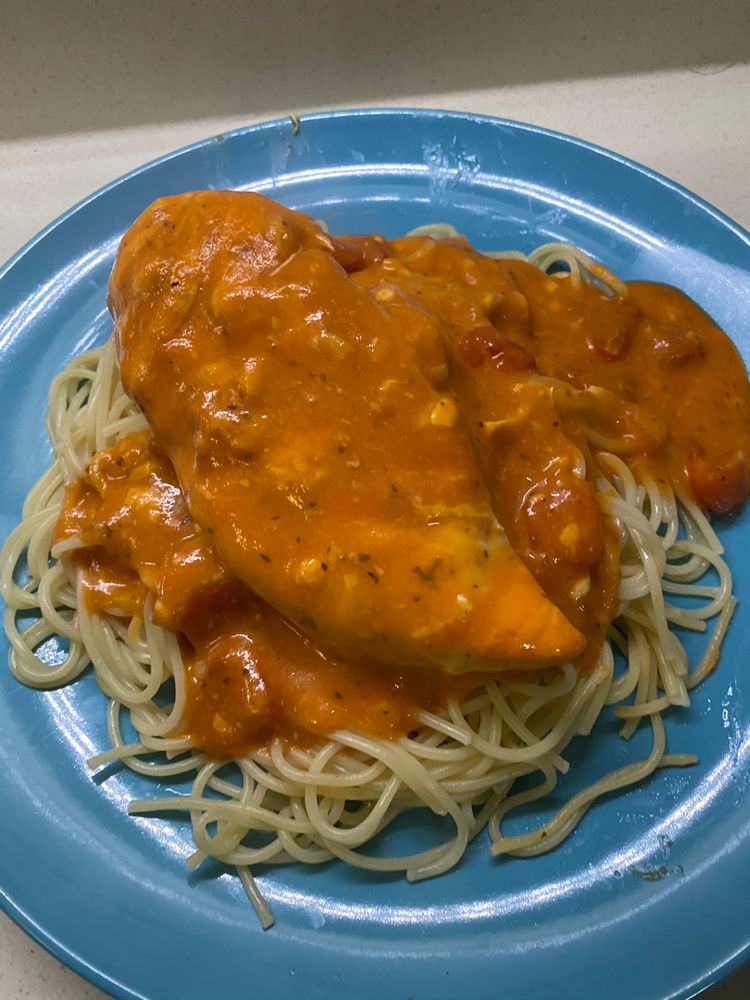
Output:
(110, 192), (585, 672)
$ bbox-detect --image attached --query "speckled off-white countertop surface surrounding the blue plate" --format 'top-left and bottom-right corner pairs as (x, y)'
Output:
(0, 0), (750, 1000)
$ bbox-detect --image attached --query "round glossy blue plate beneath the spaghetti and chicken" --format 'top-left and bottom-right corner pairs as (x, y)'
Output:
(0, 111), (750, 1000)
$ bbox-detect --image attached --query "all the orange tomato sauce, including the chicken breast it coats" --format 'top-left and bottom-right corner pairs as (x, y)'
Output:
(58, 192), (750, 755)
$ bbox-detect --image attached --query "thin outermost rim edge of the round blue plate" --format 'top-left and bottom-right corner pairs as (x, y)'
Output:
(0, 106), (750, 1000)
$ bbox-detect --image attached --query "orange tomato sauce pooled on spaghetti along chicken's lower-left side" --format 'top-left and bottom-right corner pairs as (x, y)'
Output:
(56, 432), (483, 756)
